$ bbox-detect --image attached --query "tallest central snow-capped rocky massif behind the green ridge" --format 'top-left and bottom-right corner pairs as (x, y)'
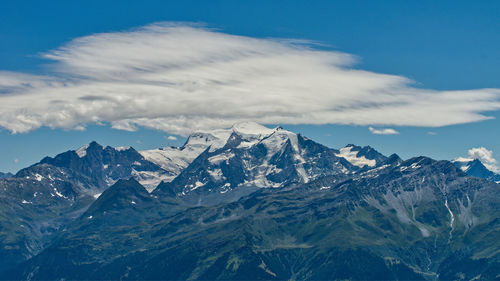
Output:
(152, 122), (387, 202)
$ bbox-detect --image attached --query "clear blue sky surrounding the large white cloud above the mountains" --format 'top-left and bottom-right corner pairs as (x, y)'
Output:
(0, 1), (500, 172)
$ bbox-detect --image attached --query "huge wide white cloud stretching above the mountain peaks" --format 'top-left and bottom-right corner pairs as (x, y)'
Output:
(0, 24), (500, 135)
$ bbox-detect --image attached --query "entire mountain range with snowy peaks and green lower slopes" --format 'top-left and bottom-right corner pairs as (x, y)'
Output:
(0, 122), (500, 280)
